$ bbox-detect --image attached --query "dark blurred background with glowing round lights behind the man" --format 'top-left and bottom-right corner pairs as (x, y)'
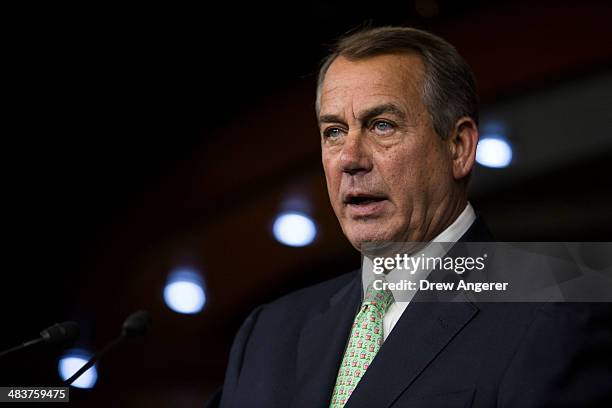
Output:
(0, 0), (612, 407)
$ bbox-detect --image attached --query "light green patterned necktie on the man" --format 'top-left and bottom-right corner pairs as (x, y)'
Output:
(329, 282), (393, 408)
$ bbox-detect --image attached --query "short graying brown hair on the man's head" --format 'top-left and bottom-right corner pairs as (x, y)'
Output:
(316, 27), (479, 139)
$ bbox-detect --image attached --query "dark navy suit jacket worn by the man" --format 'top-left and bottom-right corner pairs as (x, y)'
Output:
(208, 220), (612, 408)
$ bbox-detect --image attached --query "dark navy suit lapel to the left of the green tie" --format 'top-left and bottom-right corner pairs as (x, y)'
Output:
(292, 272), (362, 408)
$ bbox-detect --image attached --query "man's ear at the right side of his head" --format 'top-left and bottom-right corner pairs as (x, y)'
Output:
(448, 116), (479, 180)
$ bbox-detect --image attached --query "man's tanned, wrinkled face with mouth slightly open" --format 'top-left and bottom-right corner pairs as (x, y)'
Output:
(318, 54), (456, 250)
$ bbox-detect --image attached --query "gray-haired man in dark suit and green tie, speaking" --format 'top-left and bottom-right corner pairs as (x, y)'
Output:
(211, 27), (612, 407)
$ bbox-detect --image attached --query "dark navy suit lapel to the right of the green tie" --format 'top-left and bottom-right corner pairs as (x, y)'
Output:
(344, 294), (478, 408)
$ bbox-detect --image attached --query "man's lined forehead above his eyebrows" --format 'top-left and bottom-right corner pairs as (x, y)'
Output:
(320, 54), (424, 112)
